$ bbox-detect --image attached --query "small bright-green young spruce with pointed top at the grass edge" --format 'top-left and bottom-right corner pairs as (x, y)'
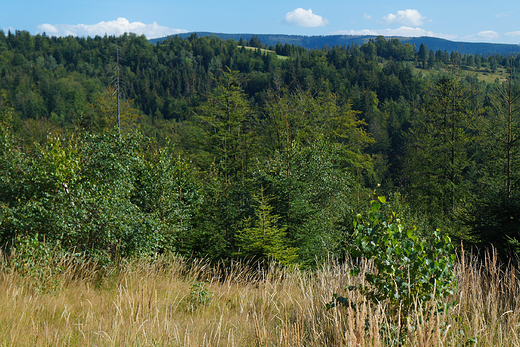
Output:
(236, 187), (298, 264)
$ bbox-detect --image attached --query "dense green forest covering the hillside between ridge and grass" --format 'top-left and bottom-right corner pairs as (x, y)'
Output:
(0, 31), (520, 266)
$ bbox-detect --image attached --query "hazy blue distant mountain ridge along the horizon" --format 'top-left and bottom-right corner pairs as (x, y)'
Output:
(149, 31), (520, 56)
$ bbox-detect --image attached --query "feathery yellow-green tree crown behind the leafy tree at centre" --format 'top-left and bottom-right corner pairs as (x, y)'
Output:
(263, 92), (375, 173)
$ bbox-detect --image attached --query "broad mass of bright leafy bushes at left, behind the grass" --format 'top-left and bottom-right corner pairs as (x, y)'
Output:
(0, 129), (200, 264)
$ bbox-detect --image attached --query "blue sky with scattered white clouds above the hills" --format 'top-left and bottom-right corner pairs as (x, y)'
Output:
(0, 0), (520, 44)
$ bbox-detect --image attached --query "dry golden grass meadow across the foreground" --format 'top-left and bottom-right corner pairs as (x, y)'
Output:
(0, 249), (520, 347)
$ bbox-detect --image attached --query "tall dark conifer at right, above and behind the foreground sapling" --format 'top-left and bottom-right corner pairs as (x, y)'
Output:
(405, 75), (482, 226)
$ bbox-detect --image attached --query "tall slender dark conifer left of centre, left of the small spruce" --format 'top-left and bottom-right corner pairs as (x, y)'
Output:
(193, 71), (254, 256)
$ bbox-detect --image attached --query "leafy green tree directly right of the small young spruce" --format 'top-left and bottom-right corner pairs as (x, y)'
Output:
(253, 139), (353, 266)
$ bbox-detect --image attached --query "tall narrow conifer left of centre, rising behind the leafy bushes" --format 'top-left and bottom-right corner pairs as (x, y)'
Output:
(198, 71), (252, 246)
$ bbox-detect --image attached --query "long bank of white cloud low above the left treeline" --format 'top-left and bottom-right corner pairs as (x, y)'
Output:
(36, 18), (187, 39)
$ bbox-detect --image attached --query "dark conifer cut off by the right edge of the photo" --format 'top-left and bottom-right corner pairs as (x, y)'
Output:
(464, 58), (520, 253)
